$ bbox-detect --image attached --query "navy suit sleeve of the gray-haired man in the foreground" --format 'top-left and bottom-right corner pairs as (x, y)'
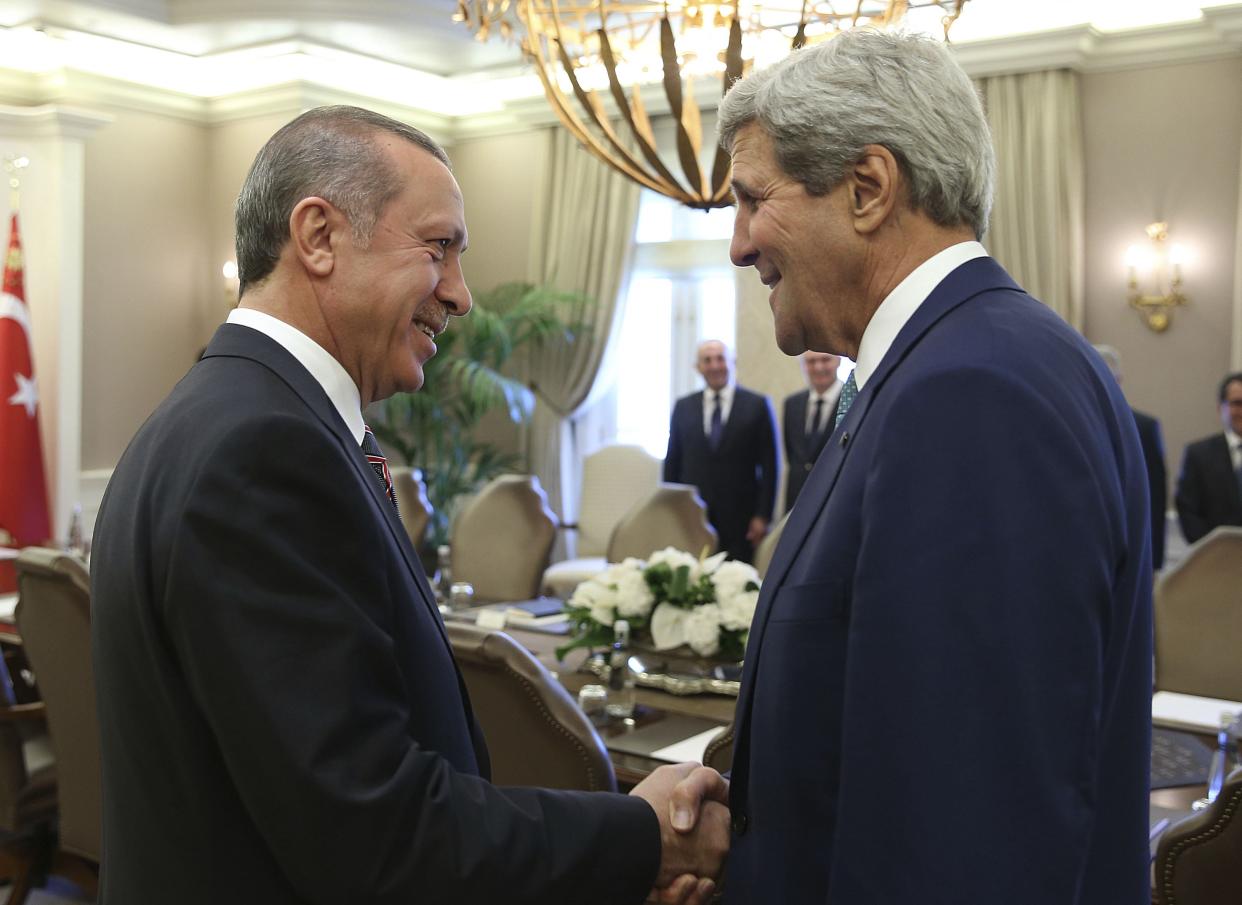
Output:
(831, 362), (1146, 905)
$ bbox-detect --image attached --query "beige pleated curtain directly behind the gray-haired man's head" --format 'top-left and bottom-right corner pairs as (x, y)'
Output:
(980, 70), (1086, 330)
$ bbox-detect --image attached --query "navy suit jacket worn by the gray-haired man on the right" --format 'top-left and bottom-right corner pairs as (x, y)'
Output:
(725, 258), (1151, 905)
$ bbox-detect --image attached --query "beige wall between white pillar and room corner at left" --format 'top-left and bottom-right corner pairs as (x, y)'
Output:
(82, 108), (211, 469)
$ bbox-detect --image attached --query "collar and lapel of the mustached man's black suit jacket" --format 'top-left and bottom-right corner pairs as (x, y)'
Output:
(204, 324), (448, 644)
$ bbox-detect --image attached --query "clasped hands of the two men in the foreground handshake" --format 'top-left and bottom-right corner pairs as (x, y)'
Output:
(630, 763), (729, 905)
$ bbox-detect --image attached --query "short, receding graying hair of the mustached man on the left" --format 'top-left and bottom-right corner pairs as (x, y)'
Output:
(235, 106), (450, 294)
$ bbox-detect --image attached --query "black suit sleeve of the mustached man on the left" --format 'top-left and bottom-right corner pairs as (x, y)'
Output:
(161, 417), (660, 905)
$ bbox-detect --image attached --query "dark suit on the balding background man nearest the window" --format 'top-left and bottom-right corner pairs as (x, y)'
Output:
(664, 386), (777, 562)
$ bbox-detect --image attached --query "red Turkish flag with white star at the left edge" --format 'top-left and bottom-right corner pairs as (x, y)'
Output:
(0, 212), (52, 592)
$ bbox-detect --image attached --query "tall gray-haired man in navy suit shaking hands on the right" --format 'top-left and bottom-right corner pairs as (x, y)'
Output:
(719, 29), (1151, 905)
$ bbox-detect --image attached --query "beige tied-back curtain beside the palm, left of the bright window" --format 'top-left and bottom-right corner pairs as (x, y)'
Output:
(527, 128), (640, 519)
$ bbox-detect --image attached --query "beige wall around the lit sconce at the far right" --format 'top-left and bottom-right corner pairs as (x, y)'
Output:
(1082, 57), (1242, 502)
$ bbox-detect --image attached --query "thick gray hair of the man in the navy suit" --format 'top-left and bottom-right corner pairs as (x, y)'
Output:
(719, 29), (996, 238)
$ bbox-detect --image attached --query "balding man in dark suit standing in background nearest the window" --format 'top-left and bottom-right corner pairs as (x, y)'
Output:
(664, 340), (777, 562)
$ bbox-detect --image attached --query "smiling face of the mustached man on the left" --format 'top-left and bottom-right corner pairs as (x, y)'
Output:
(324, 135), (471, 406)
